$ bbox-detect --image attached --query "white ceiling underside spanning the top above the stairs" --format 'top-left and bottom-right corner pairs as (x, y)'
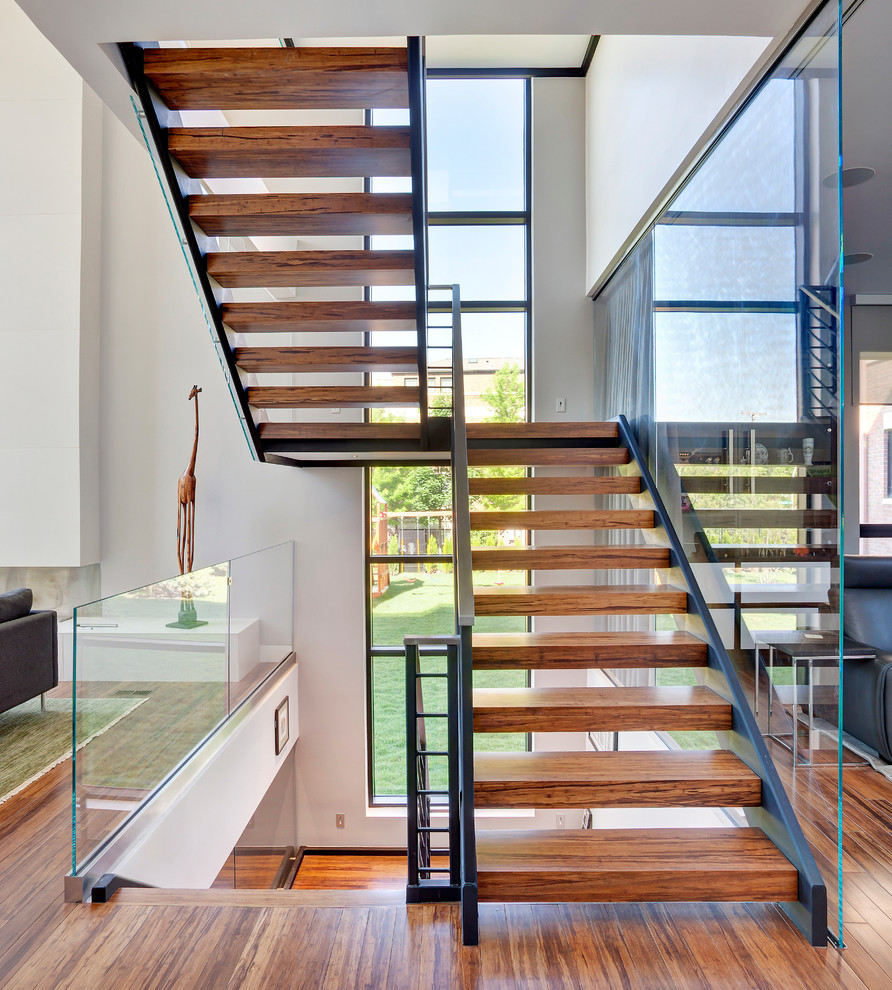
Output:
(18, 0), (806, 138)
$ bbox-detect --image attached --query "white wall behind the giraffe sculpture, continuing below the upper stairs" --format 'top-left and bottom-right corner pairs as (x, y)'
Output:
(101, 101), (386, 845)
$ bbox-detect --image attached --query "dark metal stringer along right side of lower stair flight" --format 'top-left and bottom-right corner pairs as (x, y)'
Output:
(616, 415), (827, 946)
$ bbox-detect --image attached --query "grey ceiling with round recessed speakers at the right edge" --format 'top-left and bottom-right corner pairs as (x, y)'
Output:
(842, 0), (892, 295)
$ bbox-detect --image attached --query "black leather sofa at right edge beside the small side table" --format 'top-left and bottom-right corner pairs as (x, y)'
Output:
(842, 555), (892, 763)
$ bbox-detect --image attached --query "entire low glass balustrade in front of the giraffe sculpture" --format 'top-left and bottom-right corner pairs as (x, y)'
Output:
(70, 542), (294, 874)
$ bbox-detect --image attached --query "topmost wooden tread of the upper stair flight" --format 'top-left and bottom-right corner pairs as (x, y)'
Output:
(145, 48), (409, 110)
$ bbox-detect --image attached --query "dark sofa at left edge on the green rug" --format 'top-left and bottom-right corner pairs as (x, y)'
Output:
(0, 588), (59, 713)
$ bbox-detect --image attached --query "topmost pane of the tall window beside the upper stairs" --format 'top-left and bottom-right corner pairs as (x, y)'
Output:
(427, 79), (525, 212)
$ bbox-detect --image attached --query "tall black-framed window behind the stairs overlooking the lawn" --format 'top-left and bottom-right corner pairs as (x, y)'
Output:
(366, 79), (530, 803)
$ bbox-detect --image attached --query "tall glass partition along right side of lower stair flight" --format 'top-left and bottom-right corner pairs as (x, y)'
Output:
(596, 3), (851, 937)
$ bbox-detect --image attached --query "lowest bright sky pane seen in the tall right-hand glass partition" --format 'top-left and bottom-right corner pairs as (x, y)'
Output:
(654, 313), (797, 423)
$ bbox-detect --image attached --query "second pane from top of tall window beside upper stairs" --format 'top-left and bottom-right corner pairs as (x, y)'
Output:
(429, 225), (526, 302)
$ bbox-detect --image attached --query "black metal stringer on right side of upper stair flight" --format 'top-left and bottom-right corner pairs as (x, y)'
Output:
(406, 38), (428, 450)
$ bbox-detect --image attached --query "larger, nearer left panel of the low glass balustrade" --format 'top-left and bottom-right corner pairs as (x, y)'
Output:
(72, 563), (229, 872)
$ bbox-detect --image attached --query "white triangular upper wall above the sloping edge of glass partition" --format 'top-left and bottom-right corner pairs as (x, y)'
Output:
(586, 35), (770, 289)
